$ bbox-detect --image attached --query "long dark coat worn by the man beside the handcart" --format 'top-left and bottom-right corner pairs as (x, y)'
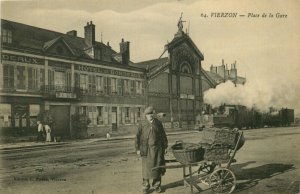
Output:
(135, 118), (168, 179)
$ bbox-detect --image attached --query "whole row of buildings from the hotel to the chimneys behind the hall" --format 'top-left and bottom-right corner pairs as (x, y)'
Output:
(0, 19), (246, 137)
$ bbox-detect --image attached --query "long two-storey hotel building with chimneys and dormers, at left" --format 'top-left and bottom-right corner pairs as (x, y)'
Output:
(0, 20), (146, 137)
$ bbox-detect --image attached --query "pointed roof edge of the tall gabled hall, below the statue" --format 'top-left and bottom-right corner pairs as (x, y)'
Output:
(166, 32), (204, 60)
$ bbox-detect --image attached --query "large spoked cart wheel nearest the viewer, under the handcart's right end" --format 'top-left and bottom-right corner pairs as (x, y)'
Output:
(209, 168), (236, 193)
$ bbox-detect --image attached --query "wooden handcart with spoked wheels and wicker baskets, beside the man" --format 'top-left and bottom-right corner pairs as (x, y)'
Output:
(153, 129), (244, 194)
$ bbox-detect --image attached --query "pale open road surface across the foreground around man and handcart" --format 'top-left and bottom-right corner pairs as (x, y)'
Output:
(0, 128), (300, 194)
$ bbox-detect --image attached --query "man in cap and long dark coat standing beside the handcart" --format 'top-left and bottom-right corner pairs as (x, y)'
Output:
(135, 106), (168, 193)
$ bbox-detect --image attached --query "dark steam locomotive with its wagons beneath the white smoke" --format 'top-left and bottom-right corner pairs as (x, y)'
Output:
(196, 104), (294, 129)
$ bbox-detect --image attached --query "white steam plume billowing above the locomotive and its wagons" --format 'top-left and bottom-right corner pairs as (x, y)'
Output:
(204, 80), (295, 111)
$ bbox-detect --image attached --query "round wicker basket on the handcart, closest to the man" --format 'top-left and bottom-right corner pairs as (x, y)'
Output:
(172, 141), (204, 164)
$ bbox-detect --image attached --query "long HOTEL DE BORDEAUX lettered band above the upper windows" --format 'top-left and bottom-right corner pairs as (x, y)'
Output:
(75, 65), (143, 78)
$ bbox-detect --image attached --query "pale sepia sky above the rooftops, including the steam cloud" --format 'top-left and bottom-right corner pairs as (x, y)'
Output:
(1, 0), (300, 114)
